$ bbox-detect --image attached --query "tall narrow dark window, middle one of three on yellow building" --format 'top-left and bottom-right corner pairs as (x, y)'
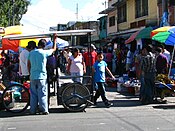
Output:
(118, 3), (127, 23)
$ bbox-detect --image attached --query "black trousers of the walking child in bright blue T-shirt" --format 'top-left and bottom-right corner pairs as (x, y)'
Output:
(94, 82), (108, 103)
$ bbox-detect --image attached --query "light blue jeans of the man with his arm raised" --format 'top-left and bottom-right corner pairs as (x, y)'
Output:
(30, 80), (48, 113)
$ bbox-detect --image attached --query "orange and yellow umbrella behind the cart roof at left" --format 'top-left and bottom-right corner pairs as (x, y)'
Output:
(2, 25), (39, 52)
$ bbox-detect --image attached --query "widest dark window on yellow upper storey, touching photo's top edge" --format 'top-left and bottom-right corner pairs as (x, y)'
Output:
(135, 0), (148, 18)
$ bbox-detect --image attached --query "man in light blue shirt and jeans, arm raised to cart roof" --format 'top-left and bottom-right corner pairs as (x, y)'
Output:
(28, 34), (57, 115)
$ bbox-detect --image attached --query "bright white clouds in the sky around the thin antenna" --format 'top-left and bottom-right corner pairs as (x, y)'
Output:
(21, 0), (105, 30)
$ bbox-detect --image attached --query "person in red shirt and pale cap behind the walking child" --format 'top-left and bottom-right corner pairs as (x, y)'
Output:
(83, 44), (97, 83)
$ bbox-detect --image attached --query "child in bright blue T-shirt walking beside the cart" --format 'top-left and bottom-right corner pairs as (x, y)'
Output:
(92, 52), (115, 107)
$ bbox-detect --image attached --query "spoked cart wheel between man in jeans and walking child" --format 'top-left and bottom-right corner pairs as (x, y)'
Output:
(61, 83), (91, 112)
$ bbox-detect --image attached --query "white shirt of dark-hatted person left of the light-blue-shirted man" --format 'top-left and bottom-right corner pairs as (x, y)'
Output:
(19, 49), (29, 76)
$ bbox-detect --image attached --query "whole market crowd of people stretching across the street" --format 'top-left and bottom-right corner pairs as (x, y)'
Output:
(0, 39), (175, 114)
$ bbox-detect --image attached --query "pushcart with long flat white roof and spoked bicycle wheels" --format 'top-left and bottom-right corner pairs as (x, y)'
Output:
(2, 29), (94, 111)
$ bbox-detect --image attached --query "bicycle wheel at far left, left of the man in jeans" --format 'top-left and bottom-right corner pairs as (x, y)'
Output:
(2, 84), (30, 113)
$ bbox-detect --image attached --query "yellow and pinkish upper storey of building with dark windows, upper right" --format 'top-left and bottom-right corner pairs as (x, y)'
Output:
(99, 0), (175, 44)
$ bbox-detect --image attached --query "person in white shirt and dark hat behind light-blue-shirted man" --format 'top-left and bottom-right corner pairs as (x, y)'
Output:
(19, 41), (36, 83)
